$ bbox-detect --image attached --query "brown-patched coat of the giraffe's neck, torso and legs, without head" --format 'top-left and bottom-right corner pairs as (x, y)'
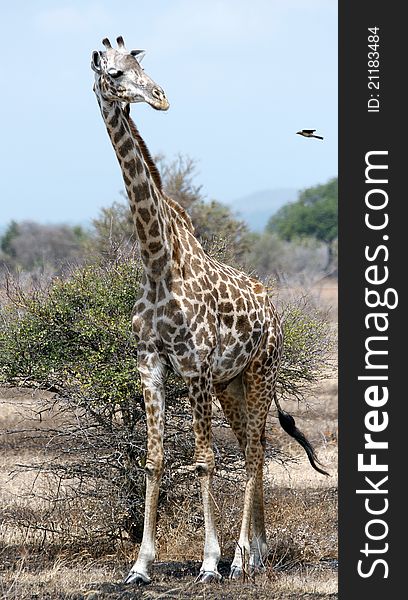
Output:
(96, 86), (290, 584)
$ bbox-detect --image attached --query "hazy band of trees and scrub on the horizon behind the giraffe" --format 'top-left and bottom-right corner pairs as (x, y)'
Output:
(0, 156), (338, 284)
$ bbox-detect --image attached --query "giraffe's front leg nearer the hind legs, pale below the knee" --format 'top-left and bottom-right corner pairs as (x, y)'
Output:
(189, 374), (221, 583)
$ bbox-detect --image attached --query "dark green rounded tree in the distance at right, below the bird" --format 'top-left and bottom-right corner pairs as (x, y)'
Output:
(266, 177), (338, 267)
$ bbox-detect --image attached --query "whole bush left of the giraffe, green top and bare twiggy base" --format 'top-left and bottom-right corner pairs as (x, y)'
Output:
(0, 258), (193, 539)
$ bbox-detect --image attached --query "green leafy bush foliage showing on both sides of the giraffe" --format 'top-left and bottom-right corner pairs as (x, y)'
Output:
(0, 262), (331, 406)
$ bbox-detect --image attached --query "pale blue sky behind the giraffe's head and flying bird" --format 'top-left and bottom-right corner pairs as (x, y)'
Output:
(0, 0), (337, 225)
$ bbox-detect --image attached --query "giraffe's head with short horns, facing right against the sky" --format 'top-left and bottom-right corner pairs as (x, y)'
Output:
(91, 37), (169, 110)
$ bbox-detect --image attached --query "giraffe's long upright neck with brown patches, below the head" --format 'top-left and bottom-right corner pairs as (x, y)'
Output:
(95, 88), (173, 279)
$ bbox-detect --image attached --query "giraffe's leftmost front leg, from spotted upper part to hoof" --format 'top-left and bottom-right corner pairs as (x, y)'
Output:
(124, 357), (165, 585)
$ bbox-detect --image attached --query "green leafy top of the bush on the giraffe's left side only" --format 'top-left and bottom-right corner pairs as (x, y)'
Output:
(0, 260), (145, 404)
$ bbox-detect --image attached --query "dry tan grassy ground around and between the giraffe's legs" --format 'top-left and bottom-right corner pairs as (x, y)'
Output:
(0, 290), (337, 600)
